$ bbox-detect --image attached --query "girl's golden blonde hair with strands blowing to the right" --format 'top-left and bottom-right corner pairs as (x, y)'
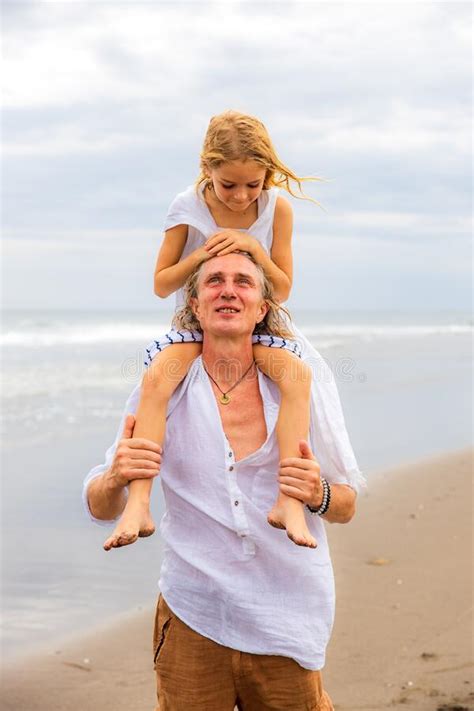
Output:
(195, 110), (324, 207)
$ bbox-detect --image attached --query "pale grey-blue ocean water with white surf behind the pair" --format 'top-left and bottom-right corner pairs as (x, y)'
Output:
(0, 311), (472, 656)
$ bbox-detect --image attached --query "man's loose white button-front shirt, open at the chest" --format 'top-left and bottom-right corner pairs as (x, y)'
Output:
(83, 357), (343, 670)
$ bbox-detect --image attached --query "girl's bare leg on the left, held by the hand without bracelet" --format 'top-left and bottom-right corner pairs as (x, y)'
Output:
(104, 343), (202, 550)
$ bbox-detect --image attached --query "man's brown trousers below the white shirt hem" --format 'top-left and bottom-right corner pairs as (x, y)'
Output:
(153, 595), (334, 711)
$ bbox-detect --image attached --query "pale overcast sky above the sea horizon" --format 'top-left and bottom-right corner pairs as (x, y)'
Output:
(2, 0), (471, 311)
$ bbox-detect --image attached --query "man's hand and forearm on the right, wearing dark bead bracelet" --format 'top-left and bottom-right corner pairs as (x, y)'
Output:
(278, 440), (357, 523)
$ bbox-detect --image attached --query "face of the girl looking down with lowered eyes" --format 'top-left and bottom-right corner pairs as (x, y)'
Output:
(209, 160), (267, 213)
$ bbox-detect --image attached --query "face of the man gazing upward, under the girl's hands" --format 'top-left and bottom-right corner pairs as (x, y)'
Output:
(192, 254), (268, 337)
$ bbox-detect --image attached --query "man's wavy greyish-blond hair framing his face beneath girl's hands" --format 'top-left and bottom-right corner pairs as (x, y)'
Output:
(173, 251), (295, 338)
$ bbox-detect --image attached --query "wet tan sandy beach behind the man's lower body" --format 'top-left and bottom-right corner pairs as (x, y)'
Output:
(2, 450), (474, 711)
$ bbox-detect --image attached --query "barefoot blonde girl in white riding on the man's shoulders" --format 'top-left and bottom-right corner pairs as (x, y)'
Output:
(104, 111), (361, 550)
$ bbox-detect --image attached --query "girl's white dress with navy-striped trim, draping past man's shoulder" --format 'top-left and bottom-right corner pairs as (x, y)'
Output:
(146, 185), (365, 491)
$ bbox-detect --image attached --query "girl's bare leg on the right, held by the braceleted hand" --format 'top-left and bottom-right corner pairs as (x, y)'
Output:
(253, 345), (317, 548)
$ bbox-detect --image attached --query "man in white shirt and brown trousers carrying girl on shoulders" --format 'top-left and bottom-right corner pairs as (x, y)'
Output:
(85, 253), (356, 711)
